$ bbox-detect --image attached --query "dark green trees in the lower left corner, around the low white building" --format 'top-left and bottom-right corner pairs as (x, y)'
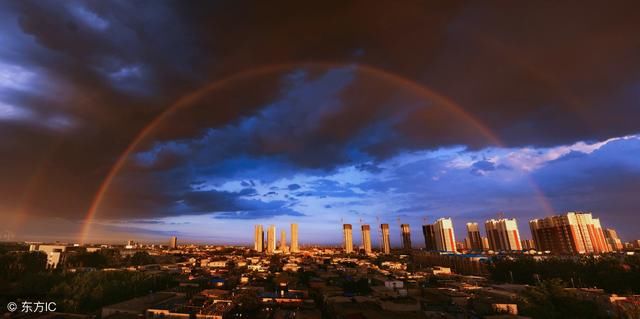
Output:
(0, 249), (177, 313)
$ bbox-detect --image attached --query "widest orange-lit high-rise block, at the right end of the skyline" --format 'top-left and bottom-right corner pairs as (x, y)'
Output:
(529, 212), (610, 254)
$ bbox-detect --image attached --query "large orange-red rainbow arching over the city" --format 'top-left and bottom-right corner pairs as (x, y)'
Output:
(79, 62), (550, 243)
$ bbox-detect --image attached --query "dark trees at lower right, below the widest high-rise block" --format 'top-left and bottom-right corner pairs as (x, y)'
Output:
(489, 255), (640, 294)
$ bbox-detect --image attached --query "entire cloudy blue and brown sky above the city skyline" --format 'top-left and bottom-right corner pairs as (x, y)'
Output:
(0, 1), (640, 247)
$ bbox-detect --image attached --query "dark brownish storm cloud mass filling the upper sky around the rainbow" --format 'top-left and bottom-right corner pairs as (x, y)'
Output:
(0, 1), (640, 225)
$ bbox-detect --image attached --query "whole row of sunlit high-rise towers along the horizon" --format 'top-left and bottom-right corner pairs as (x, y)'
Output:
(252, 212), (624, 254)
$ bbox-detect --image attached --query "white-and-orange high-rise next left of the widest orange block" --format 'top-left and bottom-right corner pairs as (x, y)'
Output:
(484, 218), (522, 251)
